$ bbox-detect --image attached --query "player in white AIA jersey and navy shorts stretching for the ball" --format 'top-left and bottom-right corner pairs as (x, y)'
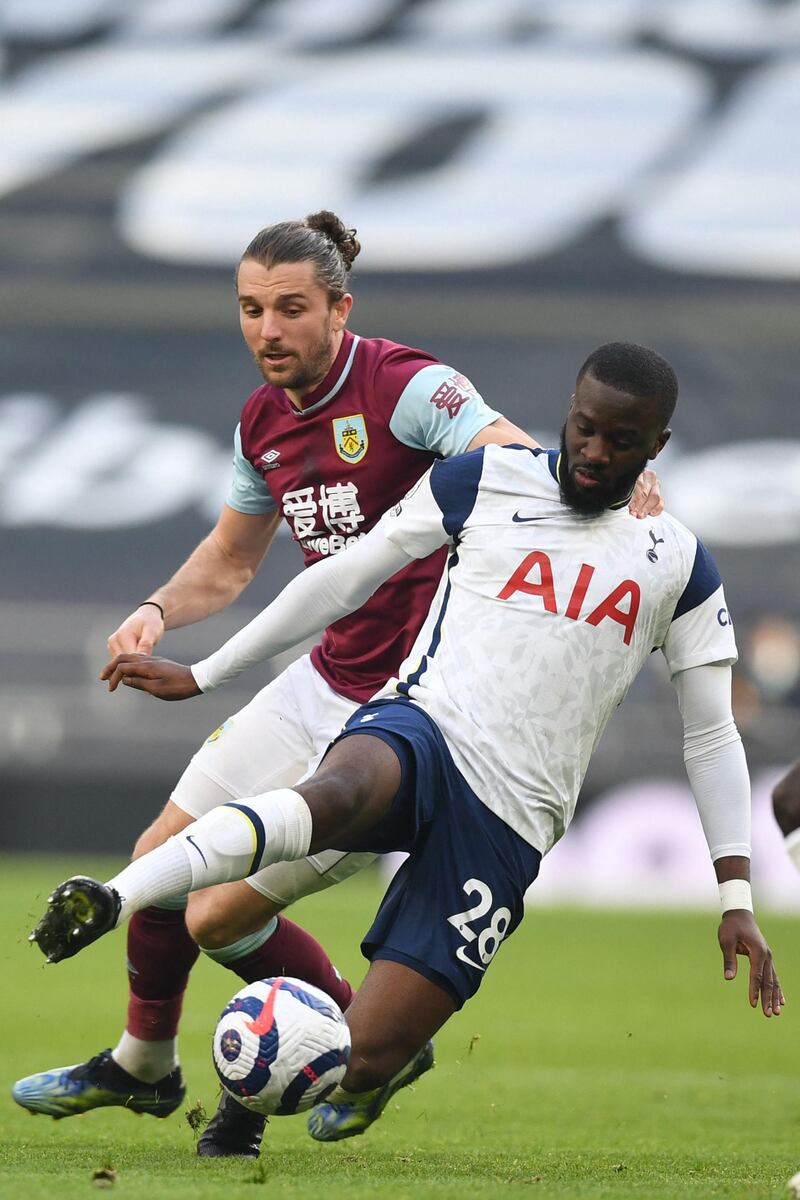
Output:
(31, 343), (783, 1140)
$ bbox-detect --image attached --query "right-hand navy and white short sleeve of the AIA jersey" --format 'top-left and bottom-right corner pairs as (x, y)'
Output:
(663, 541), (738, 676)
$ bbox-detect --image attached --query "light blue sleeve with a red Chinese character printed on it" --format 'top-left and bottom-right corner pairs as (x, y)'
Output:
(389, 362), (500, 458)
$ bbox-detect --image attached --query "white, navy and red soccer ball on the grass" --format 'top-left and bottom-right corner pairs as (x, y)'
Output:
(212, 978), (350, 1116)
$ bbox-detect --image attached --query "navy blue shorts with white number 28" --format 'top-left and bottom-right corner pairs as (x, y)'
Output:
(337, 700), (541, 1008)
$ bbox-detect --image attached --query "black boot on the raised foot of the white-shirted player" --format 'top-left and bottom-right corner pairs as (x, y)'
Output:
(28, 875), (121, 962)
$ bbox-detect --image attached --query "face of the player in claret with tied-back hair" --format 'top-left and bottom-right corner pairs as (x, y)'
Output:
(236, 258), (353, 401)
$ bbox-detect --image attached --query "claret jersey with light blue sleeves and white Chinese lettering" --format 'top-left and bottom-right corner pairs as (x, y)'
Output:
(228, 331), (499, 701)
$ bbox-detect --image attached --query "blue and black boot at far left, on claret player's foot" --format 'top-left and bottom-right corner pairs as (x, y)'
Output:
(11, 1050), (186, 1121)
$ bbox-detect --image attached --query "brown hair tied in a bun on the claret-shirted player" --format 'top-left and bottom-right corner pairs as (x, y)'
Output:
(240, 209), (361, 301)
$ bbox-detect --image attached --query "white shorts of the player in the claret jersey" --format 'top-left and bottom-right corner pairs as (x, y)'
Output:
(170, 654), (375, 905)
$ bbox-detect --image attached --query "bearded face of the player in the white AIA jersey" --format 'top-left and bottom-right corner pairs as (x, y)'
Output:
(560, 374), (669, 515)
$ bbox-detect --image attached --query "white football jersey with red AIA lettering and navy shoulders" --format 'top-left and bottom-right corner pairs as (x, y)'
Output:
(379, 445), (736, 853)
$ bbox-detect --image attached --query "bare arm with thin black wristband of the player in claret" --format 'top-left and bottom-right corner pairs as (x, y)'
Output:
(108, 504), (281, 655)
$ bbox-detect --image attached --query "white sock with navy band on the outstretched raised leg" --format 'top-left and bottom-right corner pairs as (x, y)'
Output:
(108, 787), (312, 925)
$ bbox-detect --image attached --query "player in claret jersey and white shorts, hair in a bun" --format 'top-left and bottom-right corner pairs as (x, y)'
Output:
(13, 212), (661, 1156)
